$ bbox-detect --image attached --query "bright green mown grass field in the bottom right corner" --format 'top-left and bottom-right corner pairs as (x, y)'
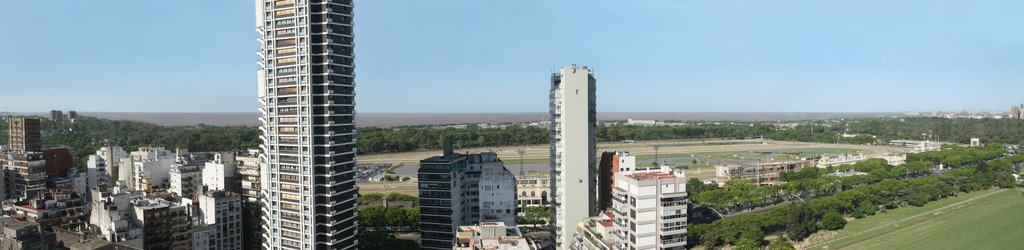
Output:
(809, 190), (1024, 249)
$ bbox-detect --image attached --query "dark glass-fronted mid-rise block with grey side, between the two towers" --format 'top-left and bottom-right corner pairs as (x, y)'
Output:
(417, 143), (517, 249)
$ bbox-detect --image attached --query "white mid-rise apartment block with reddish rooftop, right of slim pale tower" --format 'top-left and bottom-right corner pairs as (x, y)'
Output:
(611, 167), (688, 249)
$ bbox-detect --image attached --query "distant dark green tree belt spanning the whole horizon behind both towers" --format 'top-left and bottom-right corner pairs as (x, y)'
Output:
(9, 117), (1024, 162)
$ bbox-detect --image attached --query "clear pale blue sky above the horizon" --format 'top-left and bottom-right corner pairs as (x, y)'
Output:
(0, 0), (1024, 113)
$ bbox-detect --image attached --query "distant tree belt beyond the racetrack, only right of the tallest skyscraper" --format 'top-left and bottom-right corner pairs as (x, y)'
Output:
(358, 118), (1024, 154)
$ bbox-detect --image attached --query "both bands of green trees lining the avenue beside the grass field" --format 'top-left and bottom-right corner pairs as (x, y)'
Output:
(688, 145), (1024, 249)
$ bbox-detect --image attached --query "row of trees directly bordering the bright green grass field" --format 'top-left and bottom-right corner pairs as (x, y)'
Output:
(688, 147), (1024, 247)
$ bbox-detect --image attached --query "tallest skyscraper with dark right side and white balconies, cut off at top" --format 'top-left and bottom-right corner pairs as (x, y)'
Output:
(256, 0), (358, 250)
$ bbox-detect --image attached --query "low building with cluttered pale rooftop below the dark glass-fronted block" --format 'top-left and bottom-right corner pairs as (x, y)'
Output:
(452, 222), (537, 250)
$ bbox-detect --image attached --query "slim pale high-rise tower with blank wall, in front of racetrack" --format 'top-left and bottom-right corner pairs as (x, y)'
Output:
(550, 66), (597, 249)
